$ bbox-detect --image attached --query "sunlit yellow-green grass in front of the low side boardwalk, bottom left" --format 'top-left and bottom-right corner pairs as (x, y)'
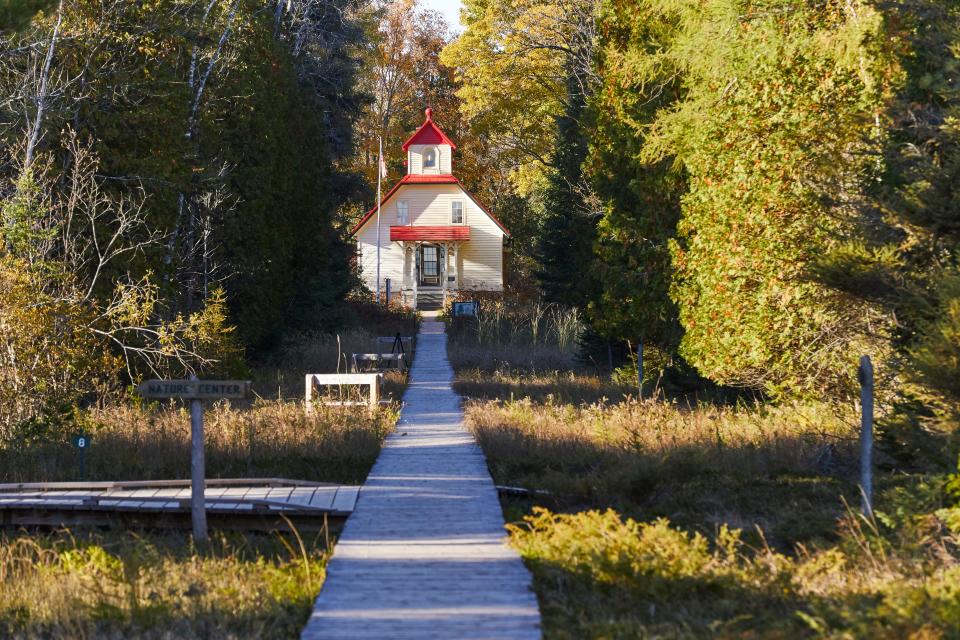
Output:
(0, 531), (328, 640)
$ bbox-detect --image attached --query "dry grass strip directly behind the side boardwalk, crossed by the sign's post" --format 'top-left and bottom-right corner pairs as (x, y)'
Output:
(0, 400), (397, 484)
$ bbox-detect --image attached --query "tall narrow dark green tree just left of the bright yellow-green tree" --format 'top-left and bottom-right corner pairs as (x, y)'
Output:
(586, 1), (685, 353)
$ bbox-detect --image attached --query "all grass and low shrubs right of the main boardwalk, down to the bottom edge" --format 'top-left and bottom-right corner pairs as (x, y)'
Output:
(466, 398), (960, 639)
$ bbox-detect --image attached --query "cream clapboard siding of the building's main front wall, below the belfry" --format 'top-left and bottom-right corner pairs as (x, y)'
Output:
(356, 184), (504, 291)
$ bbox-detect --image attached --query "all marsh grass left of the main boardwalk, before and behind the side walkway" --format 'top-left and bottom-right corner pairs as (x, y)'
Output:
(0, 305), (416, 639)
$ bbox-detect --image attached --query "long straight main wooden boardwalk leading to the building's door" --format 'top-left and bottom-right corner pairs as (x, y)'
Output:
(302, 322), (540, 640)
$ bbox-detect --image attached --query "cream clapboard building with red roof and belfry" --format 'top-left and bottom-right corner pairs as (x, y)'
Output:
(351, 109), (510, 309)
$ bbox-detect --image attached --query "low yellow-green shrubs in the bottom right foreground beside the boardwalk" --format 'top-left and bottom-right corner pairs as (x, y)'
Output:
(511, 509), (960, 638)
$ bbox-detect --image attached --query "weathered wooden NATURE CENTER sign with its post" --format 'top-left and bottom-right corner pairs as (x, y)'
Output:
(137, 376), (250, 544)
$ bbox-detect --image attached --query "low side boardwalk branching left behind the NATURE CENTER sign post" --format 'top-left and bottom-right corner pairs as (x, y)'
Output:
(0, 478), (360, 528)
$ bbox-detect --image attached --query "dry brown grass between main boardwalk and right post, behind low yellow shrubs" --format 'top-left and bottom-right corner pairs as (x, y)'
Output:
(466, 398), (856, 547)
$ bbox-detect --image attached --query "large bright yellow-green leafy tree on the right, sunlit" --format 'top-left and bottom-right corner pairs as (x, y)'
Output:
(638, 0), (894, 396)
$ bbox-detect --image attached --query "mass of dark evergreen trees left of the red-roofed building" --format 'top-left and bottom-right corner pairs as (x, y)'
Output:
(0, 0), (361, 356)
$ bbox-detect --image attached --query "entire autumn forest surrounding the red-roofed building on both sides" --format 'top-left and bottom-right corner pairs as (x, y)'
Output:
(0, 0), (960, 465)
